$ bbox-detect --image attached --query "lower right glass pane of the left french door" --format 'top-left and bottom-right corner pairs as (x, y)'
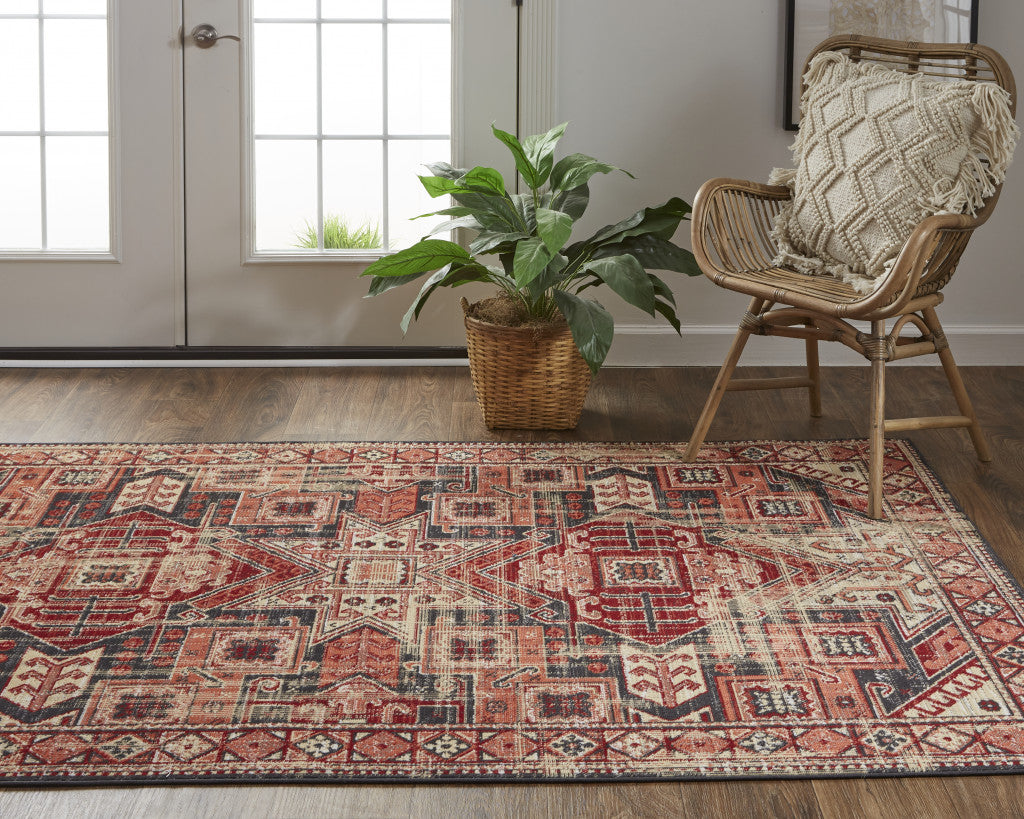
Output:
(46, 136), (111, 250)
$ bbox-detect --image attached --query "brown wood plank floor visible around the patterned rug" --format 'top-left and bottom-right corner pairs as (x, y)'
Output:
(0, 368), (1024, 819)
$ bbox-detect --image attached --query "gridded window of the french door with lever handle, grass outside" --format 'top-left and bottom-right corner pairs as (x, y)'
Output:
(250, 0), (452, 253)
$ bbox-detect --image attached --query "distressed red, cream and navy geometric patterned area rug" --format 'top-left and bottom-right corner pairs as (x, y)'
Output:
(0, 441), (1024, 784)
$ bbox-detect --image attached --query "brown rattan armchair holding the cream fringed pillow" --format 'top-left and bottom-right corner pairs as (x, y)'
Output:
(685, 35), (1016, 519)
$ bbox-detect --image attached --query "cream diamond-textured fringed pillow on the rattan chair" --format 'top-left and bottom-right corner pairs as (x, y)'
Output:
(771, 51), (1020, 293)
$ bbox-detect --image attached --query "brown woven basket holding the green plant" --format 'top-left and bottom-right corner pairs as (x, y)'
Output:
(462, 299), (590, 429)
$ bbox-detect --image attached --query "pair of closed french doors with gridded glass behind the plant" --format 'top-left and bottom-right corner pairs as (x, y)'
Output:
(0, 0), (517, 347)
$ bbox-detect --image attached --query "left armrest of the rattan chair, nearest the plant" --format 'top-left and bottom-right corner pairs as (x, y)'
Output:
(690, 178), (793, 281)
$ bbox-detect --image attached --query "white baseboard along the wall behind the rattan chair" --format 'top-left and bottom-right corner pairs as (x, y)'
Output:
(607, 325), (1024, 367)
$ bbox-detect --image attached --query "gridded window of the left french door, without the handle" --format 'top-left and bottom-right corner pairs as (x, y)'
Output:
(0, 0), (111, 254)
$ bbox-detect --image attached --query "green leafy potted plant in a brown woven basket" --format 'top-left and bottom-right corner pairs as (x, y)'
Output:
(362, 124), (700, 429)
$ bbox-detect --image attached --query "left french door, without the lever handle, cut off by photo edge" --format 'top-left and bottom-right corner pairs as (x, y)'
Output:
(0, 0), (184, 347)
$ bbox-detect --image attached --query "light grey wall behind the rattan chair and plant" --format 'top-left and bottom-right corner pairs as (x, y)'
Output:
(555, 0), (1024, 364)
